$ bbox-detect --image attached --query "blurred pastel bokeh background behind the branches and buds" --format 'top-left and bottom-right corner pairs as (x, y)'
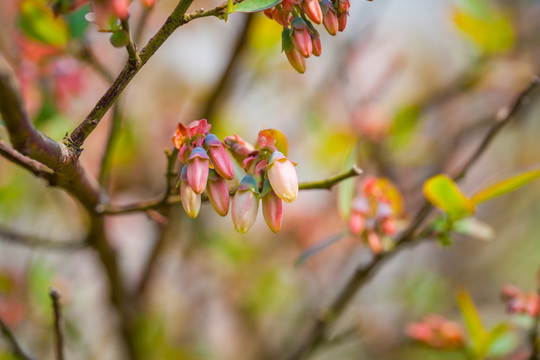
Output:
(0, 0), (540, 360)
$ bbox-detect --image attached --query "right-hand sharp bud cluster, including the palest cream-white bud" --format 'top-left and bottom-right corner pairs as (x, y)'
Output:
(224, 130), (298, 233)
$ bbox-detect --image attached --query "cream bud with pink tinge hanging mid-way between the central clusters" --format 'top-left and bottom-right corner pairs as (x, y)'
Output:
(231, 175), (259, 234)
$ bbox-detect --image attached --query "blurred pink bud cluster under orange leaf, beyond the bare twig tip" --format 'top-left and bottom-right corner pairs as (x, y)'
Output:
(349, 176), (399, 254)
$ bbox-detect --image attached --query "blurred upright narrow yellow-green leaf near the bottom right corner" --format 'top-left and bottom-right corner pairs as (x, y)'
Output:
(457, 289), (489, 359)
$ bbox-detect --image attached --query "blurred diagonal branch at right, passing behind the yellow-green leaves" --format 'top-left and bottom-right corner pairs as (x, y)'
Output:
(287, 77), (539, 360)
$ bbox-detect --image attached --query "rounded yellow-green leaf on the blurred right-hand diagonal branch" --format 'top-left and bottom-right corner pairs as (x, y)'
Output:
(424, 175), (474, 220)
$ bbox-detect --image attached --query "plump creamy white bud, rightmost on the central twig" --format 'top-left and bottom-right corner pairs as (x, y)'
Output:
(267, 151), (298, 202)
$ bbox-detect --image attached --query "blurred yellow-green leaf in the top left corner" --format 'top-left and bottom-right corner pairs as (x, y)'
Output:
(18, 0), (69, 46)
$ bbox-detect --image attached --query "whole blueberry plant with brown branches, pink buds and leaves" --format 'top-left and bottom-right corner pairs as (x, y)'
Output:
(0, 0), (540, 360)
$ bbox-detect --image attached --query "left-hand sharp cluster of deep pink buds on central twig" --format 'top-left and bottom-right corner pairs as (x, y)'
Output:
(173, 119), (234, 218)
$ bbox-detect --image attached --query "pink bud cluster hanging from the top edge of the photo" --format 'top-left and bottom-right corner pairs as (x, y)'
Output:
(264, 0), (351, 74)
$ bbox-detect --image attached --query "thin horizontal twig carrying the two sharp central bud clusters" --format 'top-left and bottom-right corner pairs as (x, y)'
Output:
(98, 166), (362, 215)
